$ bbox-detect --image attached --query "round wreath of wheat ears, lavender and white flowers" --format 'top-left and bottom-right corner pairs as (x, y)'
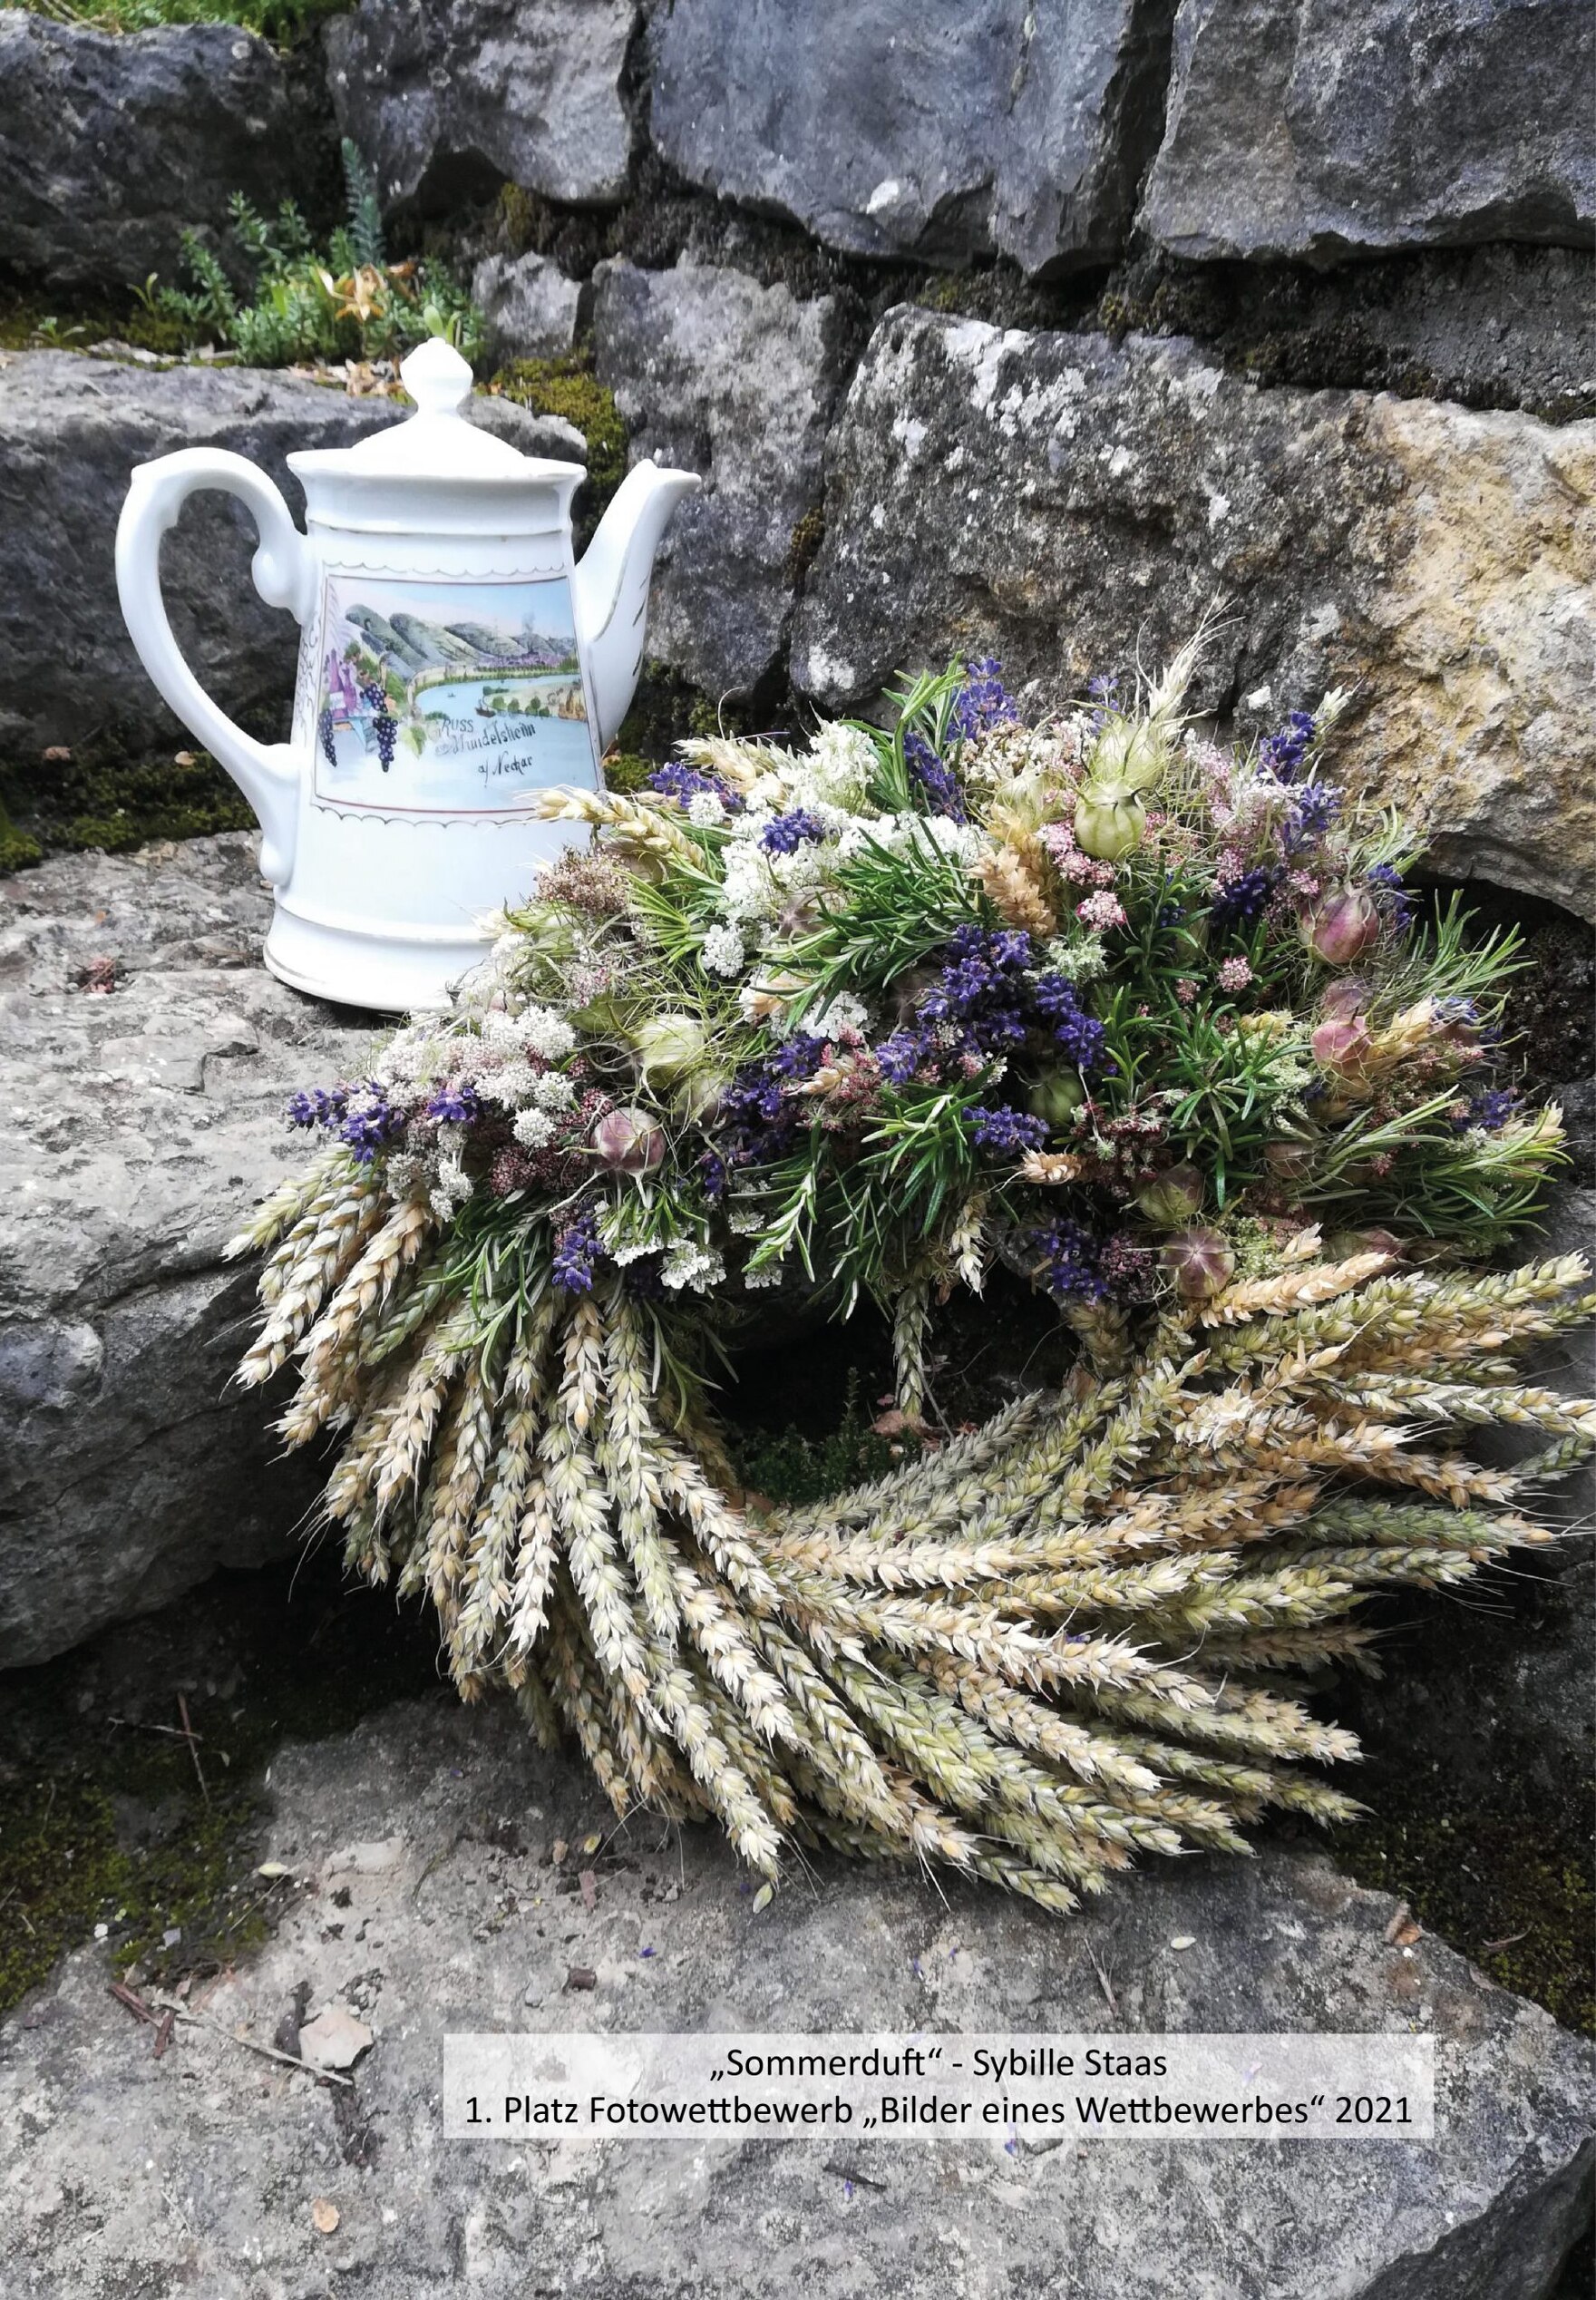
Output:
(239, 651), (1596, 1906)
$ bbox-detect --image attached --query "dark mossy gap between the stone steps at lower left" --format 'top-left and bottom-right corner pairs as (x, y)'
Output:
(0, 1554), (437, 2010)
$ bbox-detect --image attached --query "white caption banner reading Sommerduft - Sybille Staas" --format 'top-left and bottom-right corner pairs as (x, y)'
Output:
(443, 2029), (1435, 2141)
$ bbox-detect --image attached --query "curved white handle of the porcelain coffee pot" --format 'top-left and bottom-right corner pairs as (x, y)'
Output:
(117, 446), (315, 885)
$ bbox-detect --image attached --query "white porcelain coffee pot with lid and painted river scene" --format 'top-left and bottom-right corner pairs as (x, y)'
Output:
(117, 338), (699, 1012)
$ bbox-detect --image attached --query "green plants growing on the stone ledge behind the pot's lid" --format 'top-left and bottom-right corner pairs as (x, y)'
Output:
(138, 138), (483, 368)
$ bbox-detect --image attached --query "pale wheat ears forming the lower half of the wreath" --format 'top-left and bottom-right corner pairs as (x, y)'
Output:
(235, 1157), (1596, 1909)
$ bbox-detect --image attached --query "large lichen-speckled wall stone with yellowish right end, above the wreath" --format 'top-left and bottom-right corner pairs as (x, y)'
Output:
(793, 306), (1596, 913)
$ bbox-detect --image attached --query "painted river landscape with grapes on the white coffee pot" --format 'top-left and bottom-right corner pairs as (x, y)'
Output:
(315, 575), (596, 814)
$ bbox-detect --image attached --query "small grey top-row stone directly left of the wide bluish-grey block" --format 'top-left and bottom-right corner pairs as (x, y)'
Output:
(326, 0), (637, 207)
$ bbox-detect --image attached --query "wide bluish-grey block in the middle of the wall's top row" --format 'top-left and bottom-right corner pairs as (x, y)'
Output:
(651, 0), (1171, 274)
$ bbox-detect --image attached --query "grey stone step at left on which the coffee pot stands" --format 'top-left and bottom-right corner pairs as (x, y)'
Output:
(0, 833), (375, 1663)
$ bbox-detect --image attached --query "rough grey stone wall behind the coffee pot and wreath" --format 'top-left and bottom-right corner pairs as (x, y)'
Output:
(0, 0), (1596, 911)
